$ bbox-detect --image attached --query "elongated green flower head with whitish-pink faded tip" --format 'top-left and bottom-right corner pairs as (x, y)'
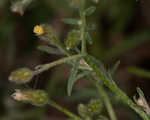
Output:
(12, 90), (48, 106)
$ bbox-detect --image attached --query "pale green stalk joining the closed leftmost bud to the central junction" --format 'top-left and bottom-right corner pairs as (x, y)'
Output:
(34, 54), (83, 75)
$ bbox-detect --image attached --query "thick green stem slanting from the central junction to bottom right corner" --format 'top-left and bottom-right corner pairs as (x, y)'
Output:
(84, 56), (149, 120)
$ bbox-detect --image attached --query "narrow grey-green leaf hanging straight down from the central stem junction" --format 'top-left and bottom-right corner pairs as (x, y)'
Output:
(67, 61), (78, 96)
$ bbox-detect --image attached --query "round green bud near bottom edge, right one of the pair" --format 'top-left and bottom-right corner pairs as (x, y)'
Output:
(88, 99), (103, 116)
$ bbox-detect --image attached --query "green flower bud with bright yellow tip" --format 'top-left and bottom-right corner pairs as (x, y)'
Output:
(33, 24), (61, 46)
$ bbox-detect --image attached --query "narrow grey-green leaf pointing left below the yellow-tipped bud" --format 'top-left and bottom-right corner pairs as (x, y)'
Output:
(38, 45), (63, 55)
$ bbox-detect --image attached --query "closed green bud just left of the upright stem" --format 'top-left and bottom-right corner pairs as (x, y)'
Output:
(66, 30), (80, 49)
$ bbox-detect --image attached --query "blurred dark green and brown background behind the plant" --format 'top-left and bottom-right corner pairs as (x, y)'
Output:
(0, 0), (150, 120)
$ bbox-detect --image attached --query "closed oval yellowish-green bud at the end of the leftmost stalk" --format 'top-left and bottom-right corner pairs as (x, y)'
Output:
(8, 68), (33, 84)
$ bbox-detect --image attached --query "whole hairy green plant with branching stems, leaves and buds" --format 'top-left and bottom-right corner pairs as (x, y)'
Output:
(9, 0), (150, 120)
